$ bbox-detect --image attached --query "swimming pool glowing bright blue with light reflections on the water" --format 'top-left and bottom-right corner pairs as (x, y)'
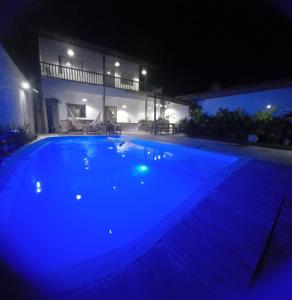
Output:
(0, 136), (238, 290)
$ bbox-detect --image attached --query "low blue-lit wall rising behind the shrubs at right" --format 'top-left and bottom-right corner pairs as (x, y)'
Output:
(198, 87), (292, 114)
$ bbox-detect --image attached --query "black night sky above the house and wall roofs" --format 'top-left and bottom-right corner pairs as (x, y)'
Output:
(0, 0), (292, 95)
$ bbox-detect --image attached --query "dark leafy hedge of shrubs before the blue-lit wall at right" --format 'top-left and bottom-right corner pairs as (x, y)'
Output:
(185, 105), (292, 145)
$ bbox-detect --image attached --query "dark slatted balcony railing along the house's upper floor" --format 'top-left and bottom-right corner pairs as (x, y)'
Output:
(40, 62), (140, 91)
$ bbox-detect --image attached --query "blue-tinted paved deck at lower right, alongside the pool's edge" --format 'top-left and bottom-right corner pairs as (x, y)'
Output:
(66, 160), (292, 300)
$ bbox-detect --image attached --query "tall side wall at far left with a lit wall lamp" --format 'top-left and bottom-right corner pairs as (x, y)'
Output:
(0, 44), (35, 133)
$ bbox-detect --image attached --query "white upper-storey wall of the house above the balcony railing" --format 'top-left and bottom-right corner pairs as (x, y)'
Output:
(39, 37), (139, 81)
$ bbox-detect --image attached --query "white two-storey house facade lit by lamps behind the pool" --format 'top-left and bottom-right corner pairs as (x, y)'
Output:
(39, 36), (189, 132)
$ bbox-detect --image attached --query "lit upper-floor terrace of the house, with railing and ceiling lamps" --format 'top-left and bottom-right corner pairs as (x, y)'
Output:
(39, 35), (147, 92)
